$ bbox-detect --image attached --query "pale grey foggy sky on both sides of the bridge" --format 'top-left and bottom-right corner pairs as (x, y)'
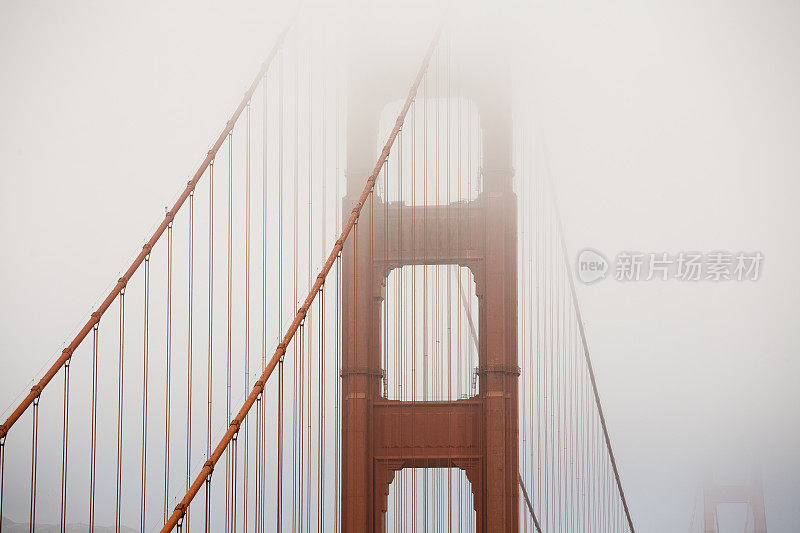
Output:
(0, 1), (800, 532)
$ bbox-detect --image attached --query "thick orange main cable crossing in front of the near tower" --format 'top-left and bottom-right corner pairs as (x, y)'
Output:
(161, 19), (441, 533)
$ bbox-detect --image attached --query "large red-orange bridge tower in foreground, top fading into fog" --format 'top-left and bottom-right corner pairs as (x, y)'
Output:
(341, 14), (519, 533)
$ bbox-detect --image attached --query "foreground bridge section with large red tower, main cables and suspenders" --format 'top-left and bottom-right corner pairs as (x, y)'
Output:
(0, 5), (634, 533)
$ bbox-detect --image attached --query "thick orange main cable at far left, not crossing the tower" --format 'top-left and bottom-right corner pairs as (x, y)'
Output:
(0, 10), (297, 437)
